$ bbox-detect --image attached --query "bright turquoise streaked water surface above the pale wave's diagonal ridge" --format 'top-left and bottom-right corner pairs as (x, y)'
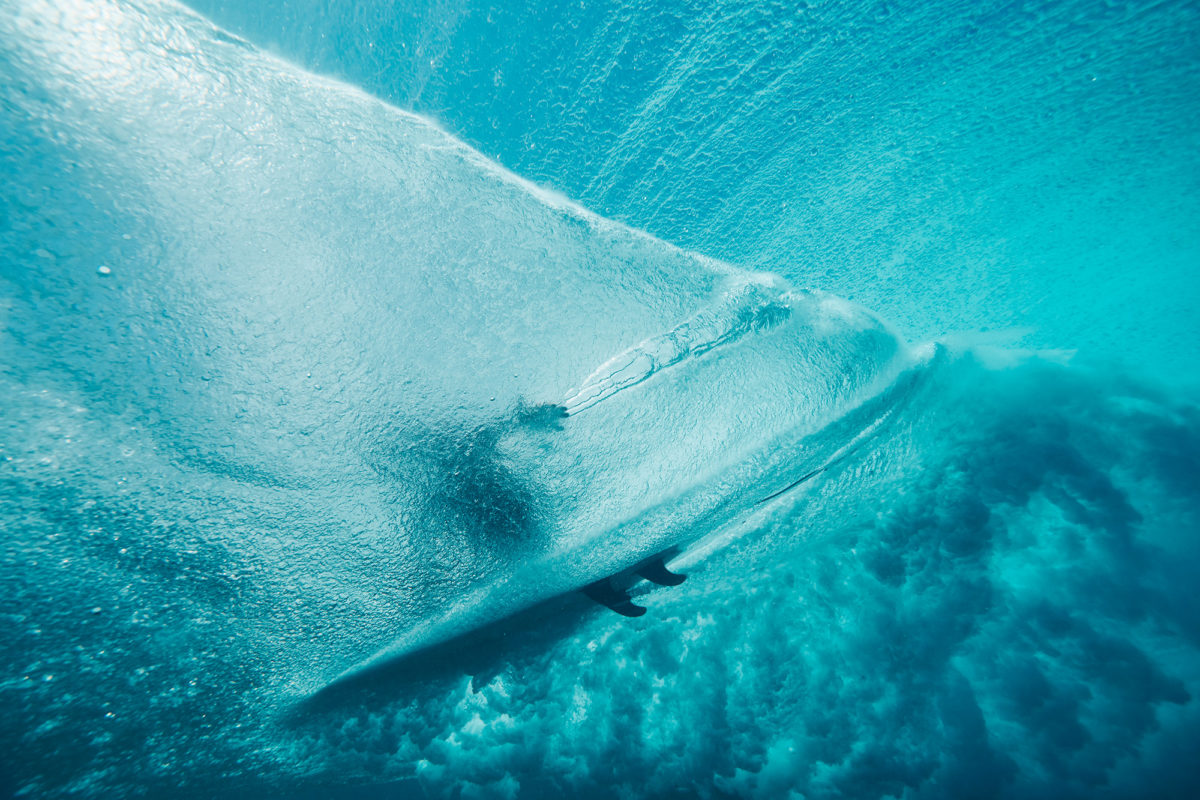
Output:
(184, 0), (1200, 386)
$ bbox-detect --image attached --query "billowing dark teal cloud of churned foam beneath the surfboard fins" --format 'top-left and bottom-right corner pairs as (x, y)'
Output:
(283, 356), (1200, 798)
